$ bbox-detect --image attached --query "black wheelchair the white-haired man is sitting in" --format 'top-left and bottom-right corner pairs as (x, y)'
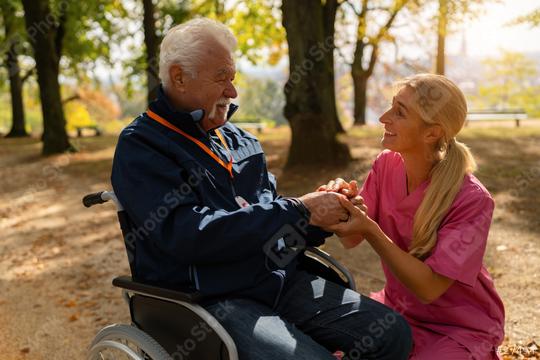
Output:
(83, 191), (356, 360)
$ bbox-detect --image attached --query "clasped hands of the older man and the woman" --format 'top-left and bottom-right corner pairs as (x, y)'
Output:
(300, 178), (373, 238)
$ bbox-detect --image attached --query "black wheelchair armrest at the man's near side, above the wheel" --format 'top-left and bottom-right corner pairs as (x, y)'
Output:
(113, 276), (204, 303)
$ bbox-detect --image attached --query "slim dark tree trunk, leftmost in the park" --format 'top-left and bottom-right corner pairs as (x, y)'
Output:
(5, 23), (28, 137)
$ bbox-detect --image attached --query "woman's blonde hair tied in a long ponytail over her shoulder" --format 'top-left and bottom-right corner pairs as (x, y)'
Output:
(400, 74), (476, 260)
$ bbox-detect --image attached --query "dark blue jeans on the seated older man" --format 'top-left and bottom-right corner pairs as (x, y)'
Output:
(207, 271), (412, 360)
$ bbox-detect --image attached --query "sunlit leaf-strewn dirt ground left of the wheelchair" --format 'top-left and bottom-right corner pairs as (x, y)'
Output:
(0, 139), (129, 359)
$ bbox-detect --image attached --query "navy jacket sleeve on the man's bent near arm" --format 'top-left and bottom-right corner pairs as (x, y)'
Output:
(111, 133), (306, 265)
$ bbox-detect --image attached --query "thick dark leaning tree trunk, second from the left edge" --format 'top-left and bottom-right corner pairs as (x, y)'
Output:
(23, 0), (73, 155)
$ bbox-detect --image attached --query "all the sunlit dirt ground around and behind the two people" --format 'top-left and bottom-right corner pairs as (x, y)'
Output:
(0, 130), (540, 360)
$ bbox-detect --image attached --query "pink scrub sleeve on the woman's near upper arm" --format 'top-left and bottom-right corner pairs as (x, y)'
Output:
(425, 188), (494, 286)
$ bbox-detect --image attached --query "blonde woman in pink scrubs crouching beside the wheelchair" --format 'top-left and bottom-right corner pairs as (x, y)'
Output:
(320, 74), (504, 360)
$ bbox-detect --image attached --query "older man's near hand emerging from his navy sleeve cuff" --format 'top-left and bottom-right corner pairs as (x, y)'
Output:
(299, 191), (349, 227)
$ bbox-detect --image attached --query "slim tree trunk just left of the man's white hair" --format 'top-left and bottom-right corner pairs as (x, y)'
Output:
(143, 0), (160, 103)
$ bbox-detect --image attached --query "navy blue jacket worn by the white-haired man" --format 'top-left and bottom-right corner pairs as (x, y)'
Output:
(111, 90), (330, 306)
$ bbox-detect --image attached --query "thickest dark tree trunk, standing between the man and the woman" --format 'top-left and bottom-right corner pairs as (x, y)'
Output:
(282, 0), (351, 168)
